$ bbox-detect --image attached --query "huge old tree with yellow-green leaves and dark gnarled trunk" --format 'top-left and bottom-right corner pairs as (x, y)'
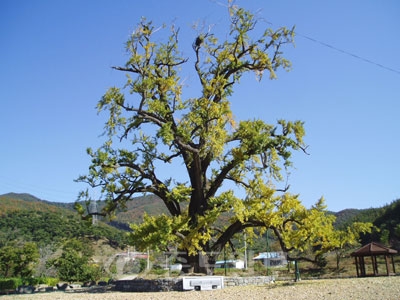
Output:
(78, 6), (342, 274)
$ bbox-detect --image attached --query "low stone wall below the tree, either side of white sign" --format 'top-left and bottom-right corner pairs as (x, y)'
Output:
(115, 276), (274, 292)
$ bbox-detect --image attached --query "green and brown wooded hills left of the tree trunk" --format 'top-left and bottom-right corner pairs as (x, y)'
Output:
(0, 193), (167, 247)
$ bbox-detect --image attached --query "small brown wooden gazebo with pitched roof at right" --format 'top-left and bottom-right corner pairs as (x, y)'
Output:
(351, 242), (397, 277)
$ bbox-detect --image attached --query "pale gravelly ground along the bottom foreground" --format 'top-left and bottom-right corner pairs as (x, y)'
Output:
(0, 276), (400, 300)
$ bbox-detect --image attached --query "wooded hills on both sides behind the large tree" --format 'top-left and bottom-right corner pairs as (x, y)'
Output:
(0, 193), (400, 249)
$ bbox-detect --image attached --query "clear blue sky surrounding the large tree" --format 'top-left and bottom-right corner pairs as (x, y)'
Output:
(0, 0), (400, 211)
